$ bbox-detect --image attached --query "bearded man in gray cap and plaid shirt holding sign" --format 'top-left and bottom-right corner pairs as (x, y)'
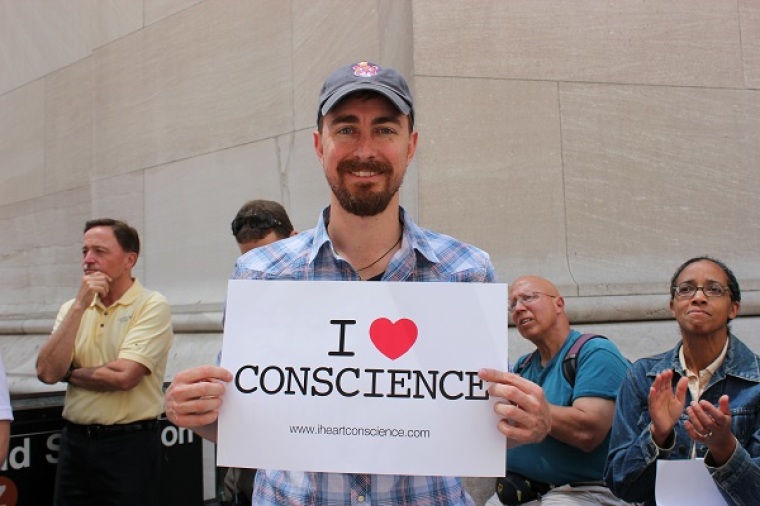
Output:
(166, 61), (495, 506)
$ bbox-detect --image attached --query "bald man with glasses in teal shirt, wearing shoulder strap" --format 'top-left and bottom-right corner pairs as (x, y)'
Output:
(486, 276), (629, 506)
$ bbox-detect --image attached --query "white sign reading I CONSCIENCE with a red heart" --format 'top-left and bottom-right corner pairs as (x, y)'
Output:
(217, 280), (507, 476)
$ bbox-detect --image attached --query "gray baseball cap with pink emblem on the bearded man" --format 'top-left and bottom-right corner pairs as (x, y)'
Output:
(317, 61), (414, 117)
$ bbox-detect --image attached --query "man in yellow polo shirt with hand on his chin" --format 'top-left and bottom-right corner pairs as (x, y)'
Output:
(37, 218), (173, 506)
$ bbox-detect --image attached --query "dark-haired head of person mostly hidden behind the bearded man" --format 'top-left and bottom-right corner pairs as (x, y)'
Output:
(232, 200), (296, 255)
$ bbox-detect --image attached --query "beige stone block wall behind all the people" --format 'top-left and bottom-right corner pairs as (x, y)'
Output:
(0, 0), (760, 498)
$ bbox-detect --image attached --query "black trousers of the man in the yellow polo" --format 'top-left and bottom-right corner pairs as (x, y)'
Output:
(53, 425), (161, 506)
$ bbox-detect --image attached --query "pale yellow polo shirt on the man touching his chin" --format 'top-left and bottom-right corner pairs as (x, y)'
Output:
(55, 279), (174, 425)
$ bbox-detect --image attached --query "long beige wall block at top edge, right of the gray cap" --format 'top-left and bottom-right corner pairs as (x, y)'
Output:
(414, 0), (743, 87)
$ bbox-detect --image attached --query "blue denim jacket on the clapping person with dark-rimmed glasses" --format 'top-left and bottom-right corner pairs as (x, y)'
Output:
(604, 334), (760, 506)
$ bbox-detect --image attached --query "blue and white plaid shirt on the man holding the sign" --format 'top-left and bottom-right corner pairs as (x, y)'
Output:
(233, 207), (496, 506)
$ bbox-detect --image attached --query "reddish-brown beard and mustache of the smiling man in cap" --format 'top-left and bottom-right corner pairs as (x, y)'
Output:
(328, 160), (403, 216)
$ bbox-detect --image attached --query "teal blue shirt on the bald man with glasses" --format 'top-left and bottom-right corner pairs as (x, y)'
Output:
(507, 330), (630, 485)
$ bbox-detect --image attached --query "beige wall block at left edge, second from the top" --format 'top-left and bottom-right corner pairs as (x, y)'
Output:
(0, 80), (45, 205)
